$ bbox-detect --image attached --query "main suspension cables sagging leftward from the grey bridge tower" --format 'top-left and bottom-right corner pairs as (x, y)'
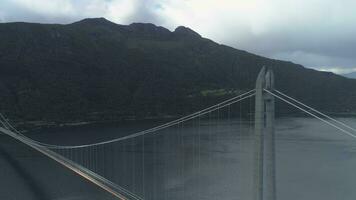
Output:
(14, 89), (255, 149)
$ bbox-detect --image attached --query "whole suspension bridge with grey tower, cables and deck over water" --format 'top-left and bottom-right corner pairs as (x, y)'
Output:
(0, 67), (356, 200)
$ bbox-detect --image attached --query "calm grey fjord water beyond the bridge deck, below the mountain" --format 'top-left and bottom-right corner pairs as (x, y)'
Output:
(13, 118), (356, 200)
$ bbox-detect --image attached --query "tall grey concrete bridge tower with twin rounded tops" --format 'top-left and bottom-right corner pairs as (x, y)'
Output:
(253, 67), (276, 200)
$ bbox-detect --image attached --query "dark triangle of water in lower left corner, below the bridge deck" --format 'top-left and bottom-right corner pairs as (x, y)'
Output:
(0, 133), (115, 200)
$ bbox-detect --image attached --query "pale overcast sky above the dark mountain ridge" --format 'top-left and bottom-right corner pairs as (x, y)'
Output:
(0, 0), (356, 73)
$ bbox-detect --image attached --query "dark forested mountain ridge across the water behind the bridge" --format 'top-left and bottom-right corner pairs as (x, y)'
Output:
(0, 18), (356, 122)
